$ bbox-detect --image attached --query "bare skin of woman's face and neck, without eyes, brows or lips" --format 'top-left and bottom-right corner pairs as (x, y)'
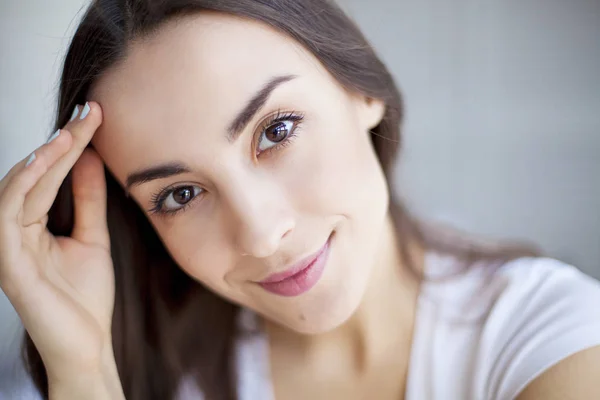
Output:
(92, 13), (418, 398)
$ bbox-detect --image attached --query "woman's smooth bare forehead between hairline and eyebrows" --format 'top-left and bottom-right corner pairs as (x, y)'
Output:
(93, 12), (329, 178)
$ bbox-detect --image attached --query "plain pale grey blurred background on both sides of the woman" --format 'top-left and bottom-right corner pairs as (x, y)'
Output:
(0, 0), (600, 398)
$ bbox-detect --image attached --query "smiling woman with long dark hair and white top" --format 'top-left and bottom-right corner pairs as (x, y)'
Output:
(0, 0), (600, 400)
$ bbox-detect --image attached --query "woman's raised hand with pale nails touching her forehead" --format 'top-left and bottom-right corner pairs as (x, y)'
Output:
(0, 102), (115, 380)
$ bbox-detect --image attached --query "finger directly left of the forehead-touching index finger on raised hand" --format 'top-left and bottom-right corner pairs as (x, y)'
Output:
(0, 134), (71, 228)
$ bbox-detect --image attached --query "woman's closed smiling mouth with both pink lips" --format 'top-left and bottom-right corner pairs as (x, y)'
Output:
(258, 233), (333, 297)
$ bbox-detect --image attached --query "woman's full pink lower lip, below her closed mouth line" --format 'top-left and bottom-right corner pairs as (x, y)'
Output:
(259, 237), (331, 297)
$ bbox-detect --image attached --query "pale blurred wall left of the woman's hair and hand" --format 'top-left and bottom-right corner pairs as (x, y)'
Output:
(0, 0), (88, 400)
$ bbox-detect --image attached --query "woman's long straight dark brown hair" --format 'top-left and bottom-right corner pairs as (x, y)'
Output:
(23, 0), (530, 400)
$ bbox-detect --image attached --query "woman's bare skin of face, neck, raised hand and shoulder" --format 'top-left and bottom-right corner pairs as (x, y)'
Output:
(0, 13), (600, 400)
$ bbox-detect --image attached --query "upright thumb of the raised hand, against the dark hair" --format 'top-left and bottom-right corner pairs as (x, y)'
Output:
(71, 148), (110, 249)
